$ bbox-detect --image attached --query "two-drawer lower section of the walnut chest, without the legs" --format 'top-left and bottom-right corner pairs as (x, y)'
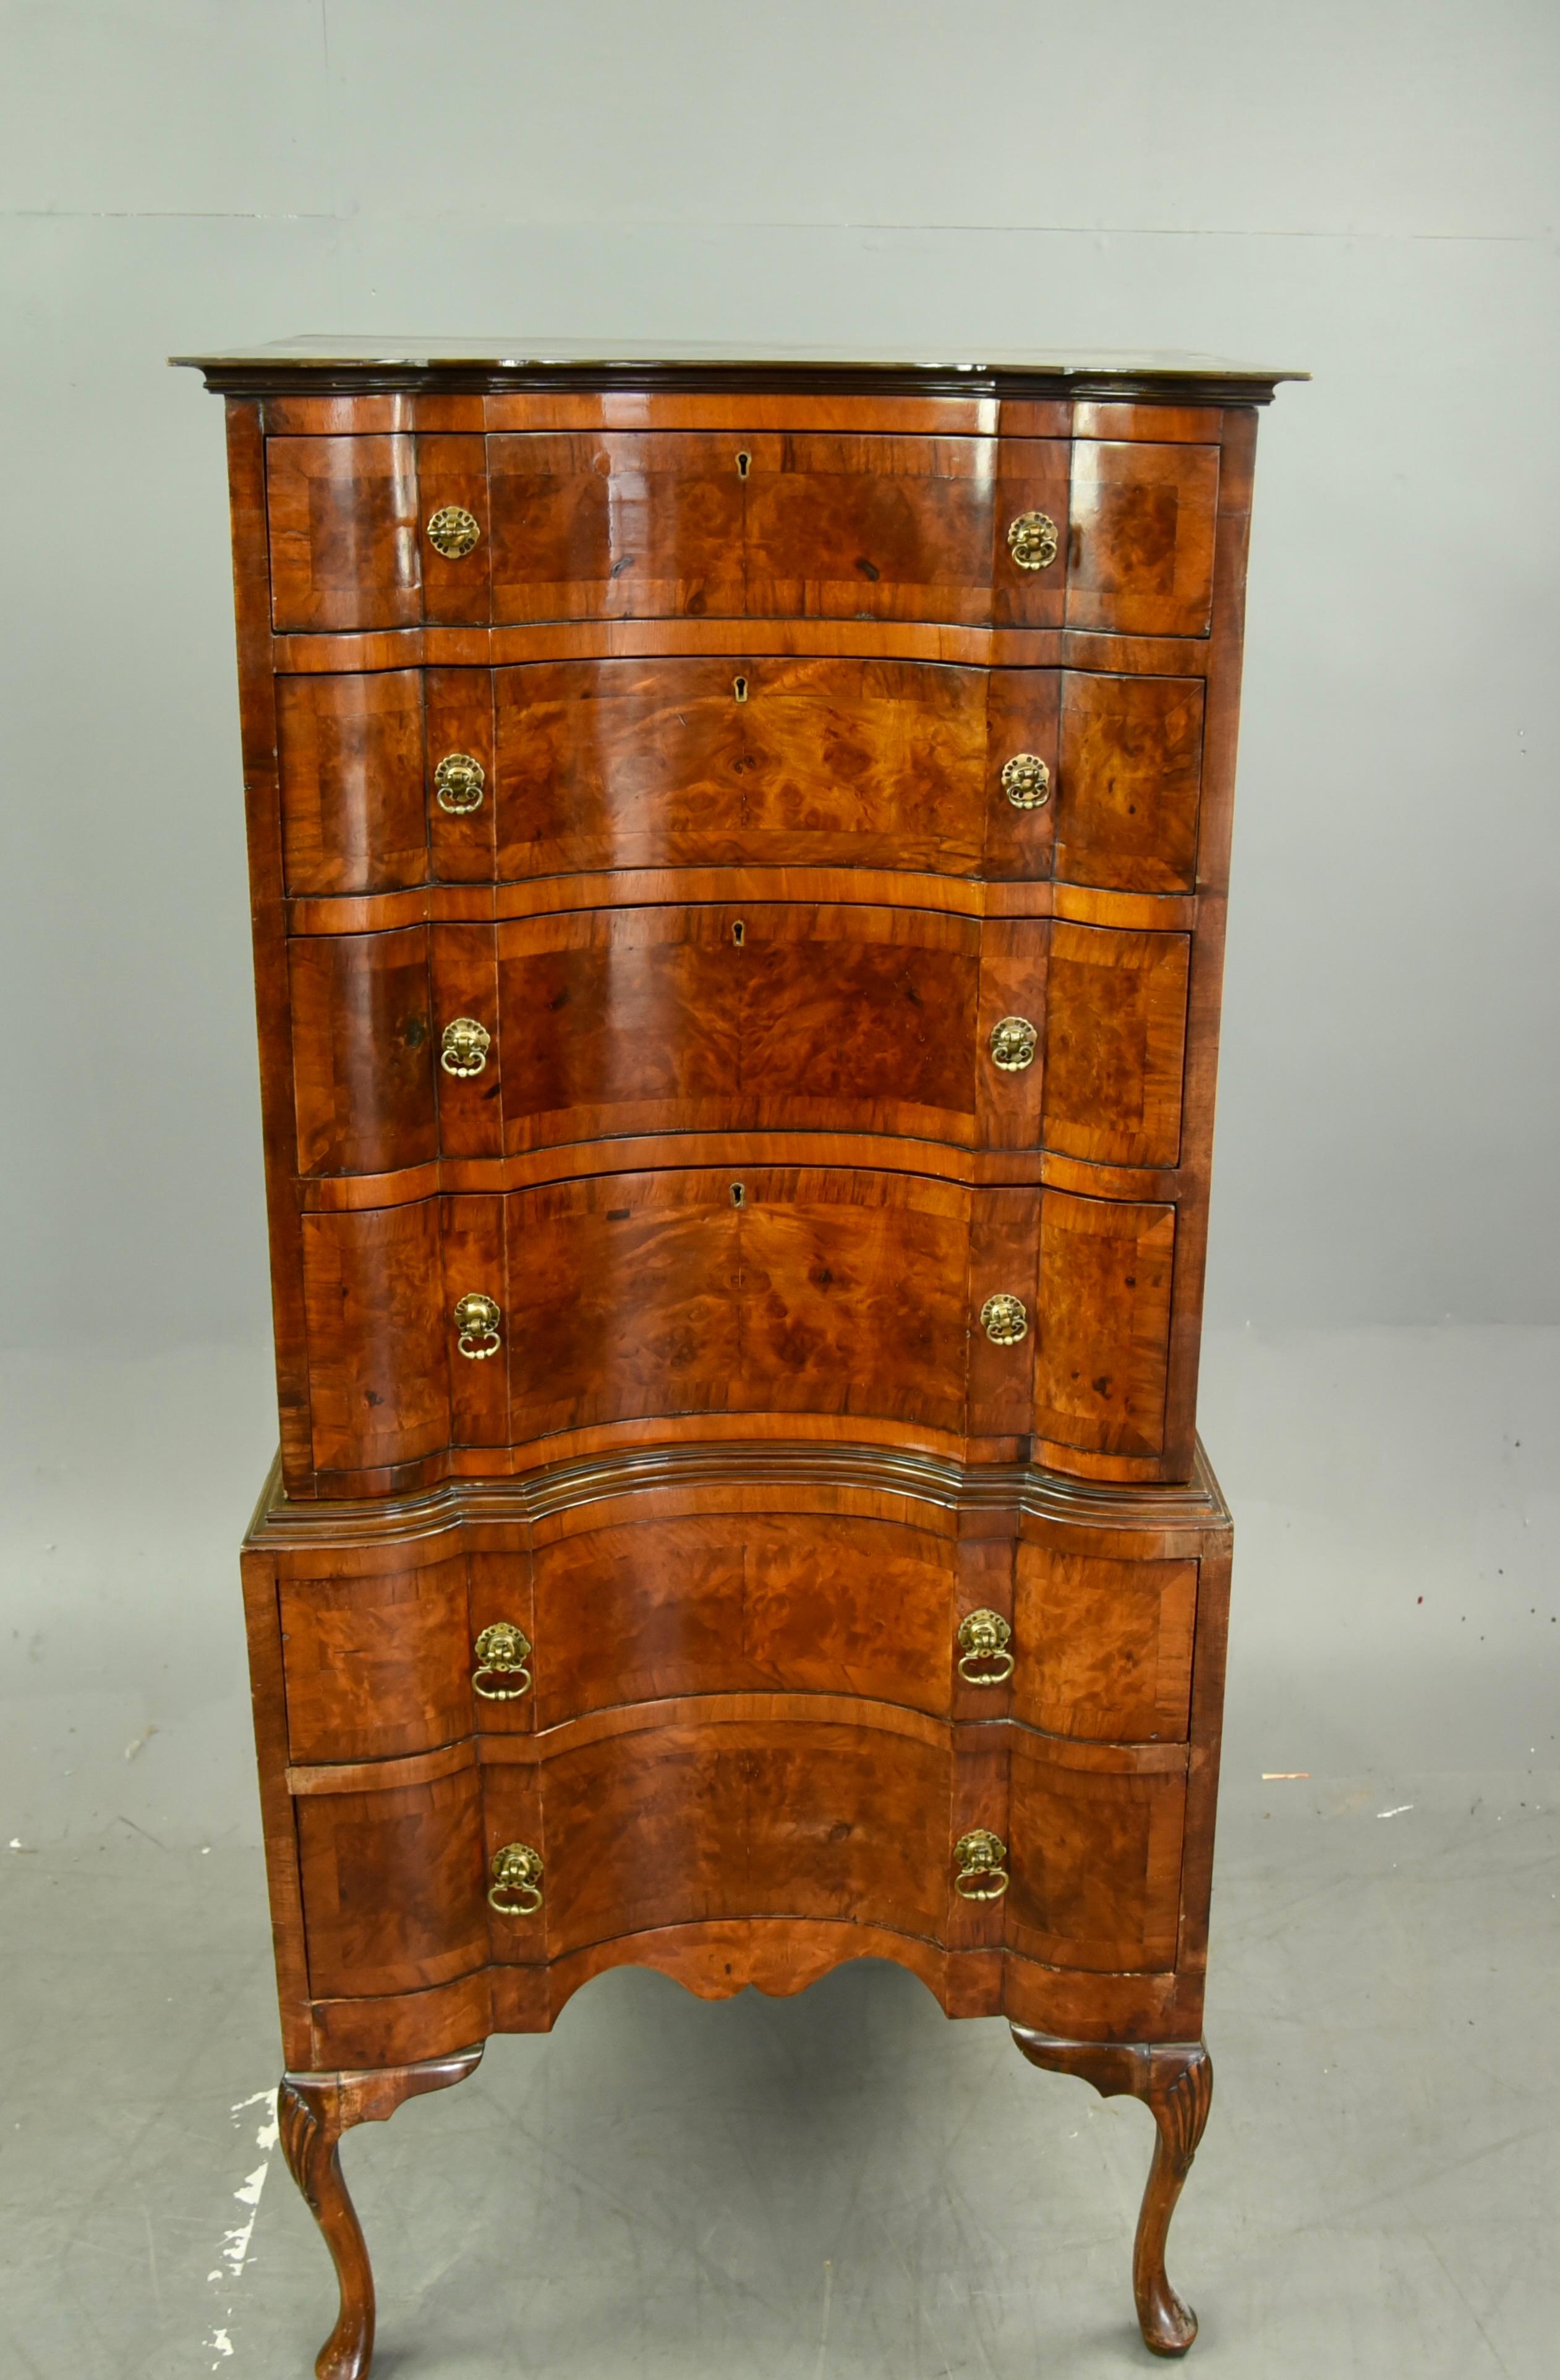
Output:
(257, 1487), (1219, 2039)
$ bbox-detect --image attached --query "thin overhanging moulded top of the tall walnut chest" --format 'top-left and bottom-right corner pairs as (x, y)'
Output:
(169, 333), (1310, 405)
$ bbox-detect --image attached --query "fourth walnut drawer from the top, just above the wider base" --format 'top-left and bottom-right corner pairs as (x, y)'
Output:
(302, 1167), (1195, 1495)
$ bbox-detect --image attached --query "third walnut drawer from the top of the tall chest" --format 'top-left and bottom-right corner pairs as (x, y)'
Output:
(288, 902), (1191, 1176)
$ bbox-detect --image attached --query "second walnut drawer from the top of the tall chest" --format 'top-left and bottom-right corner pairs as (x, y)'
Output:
(276, 650), (1203, 895)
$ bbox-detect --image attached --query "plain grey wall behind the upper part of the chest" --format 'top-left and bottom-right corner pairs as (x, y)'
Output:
(0, 0), (1560, 1349)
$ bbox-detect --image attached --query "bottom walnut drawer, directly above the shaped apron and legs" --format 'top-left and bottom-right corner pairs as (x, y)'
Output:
(296, 1694), (1186, 1997)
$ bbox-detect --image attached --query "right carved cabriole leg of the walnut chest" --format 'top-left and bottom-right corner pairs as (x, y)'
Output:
(1012, 2025), (1213, 2357)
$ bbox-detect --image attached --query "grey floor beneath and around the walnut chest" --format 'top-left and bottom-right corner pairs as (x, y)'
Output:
(0, 1333), (1560, 2380)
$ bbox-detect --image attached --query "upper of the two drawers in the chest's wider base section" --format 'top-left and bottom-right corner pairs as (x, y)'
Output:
(276, 1497), (1198, 1764)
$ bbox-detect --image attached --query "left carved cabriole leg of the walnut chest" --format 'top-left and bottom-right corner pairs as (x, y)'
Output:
(276, 2044), (481, 2380)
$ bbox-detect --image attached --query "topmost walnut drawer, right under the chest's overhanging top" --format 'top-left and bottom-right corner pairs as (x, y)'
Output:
(266, 431), (1219, 635)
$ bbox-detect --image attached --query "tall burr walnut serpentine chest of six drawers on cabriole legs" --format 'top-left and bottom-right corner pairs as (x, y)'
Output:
(185, 345), (1286, 2380)
